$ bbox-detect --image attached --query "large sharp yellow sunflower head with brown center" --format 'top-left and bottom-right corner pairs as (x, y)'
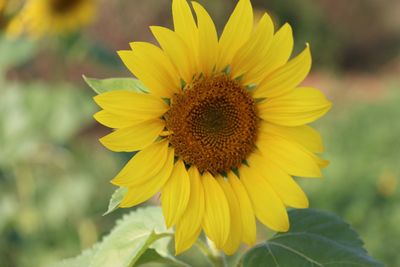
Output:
(94, 0), (331, 254)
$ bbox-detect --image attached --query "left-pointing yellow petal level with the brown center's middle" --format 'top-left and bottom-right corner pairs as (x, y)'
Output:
(100, 119), (165, 152)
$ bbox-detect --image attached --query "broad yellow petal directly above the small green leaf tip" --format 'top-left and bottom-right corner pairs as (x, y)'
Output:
(118, 42), (180, 97)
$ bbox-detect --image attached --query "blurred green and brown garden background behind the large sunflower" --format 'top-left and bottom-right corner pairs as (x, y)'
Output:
(0, 0), (400, 267)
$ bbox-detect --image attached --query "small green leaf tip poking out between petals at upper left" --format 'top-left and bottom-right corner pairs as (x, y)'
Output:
(83, 75), (148, 94)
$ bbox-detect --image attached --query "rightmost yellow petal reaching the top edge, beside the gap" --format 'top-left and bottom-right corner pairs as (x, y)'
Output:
(217, 0), (253, 71)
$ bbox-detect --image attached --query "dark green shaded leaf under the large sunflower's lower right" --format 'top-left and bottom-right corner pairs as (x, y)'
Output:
(243, 209), (383, 267)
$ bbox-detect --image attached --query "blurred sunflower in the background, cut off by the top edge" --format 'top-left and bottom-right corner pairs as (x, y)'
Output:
(7, 0), (96, 37)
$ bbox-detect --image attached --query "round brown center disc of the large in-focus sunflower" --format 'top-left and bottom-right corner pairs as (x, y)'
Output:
(165, 75), (258, 175)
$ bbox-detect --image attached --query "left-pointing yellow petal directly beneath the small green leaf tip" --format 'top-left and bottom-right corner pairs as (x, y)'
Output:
(94, 90), (168, 121)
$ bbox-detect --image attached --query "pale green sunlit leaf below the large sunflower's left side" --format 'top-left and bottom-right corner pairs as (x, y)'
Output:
(51, 207), (175, 267)
